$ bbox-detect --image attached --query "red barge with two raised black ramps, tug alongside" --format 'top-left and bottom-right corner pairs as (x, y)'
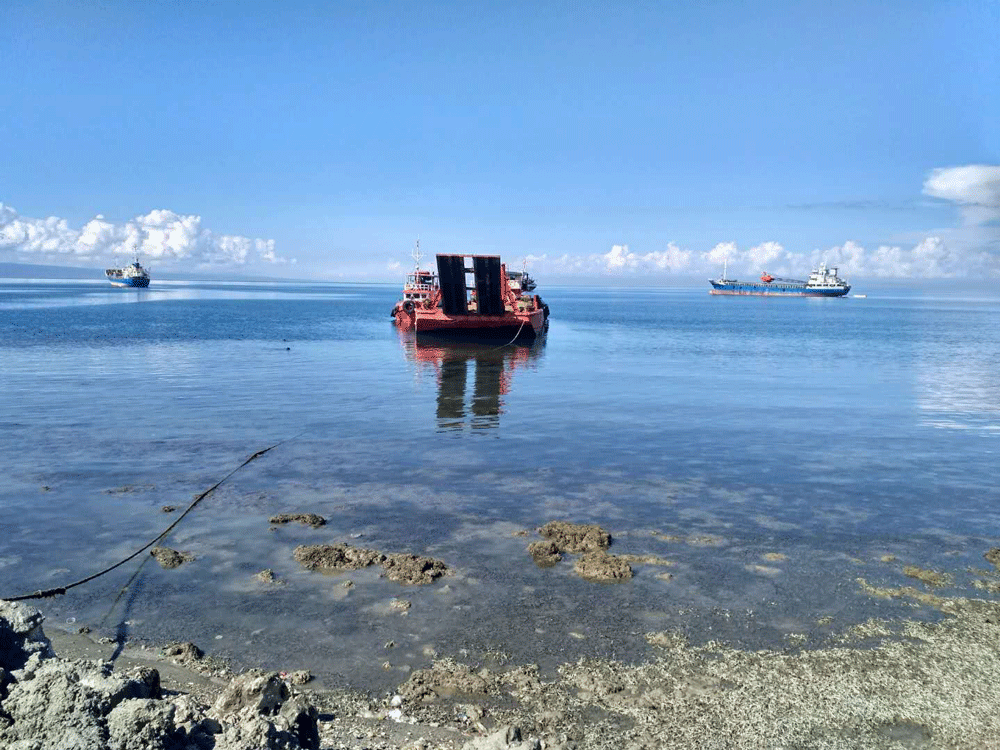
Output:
(392, 255), (549, 343)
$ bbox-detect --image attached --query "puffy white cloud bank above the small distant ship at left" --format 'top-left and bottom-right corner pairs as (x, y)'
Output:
(0, 203), (295, 268)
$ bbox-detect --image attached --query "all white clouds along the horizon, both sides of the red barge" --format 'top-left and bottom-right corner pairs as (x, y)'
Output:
(0, 164), (1000, 279)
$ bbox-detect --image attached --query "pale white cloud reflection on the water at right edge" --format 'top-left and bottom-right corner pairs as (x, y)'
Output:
(916, 340), (1000, 432)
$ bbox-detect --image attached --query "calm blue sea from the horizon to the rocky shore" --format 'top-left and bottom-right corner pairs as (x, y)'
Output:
(0, 279), (1000, 690)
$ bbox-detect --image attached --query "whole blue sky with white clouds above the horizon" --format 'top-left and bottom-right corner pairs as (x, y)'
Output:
(0, 0), (1000, 284)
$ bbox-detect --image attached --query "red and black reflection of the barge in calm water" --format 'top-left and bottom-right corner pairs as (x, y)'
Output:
(400, 332), (545, 430)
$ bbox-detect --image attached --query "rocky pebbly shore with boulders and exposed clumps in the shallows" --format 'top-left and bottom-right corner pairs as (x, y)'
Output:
(0, 536), (1000, 750)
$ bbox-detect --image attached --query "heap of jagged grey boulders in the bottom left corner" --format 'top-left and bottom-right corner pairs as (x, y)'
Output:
(0, 601), (319, 750)
